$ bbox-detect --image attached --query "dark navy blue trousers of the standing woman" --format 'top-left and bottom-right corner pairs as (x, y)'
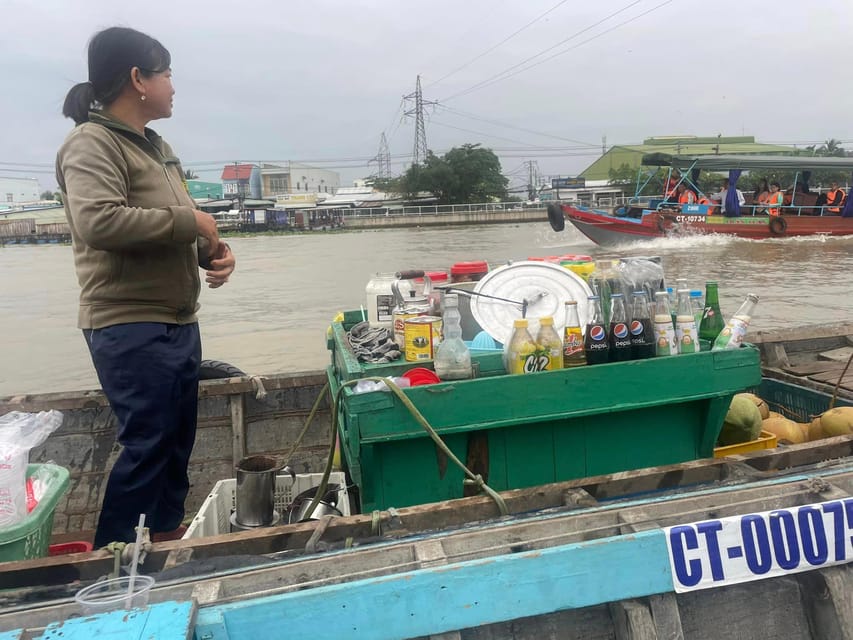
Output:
(83, 322), (201, 548)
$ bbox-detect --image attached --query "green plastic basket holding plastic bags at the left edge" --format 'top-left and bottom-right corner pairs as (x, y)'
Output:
(0, 464), (68, 562)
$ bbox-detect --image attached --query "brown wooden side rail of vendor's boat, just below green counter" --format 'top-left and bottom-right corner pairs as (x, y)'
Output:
(0, 436), (853, 589)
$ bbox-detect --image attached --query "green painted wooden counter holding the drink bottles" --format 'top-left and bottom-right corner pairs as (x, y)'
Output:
(327, 313), (761, 512)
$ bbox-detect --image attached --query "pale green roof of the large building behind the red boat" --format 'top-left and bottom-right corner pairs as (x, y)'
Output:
(580, 136), (795, 180)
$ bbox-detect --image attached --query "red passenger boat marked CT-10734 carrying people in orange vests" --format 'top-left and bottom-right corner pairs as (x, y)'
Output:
(548, 154), (853, 245)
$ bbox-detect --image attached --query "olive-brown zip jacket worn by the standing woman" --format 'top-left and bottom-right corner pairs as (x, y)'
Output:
(56, 112), (201, 329)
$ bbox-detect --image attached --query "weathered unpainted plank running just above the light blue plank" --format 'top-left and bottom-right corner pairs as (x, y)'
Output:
(0, 467), (853, 638)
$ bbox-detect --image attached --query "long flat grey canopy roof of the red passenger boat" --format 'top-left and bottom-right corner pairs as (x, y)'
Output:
(642, 153), (853, 171)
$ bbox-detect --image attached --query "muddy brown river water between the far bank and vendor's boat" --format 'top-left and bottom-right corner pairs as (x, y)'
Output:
(0, 222), (853, 396)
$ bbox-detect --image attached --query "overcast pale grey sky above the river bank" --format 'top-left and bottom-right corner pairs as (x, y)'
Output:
(0, 0), (853, 188)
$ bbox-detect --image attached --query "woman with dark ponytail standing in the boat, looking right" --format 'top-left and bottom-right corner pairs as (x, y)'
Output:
(56, 27), (235, 547)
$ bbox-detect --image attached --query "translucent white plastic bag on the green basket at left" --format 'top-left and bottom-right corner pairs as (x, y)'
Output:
(0, 411), (62, 527)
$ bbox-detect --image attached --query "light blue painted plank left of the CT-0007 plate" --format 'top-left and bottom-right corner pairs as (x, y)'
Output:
(191, 531), (672, 640)
